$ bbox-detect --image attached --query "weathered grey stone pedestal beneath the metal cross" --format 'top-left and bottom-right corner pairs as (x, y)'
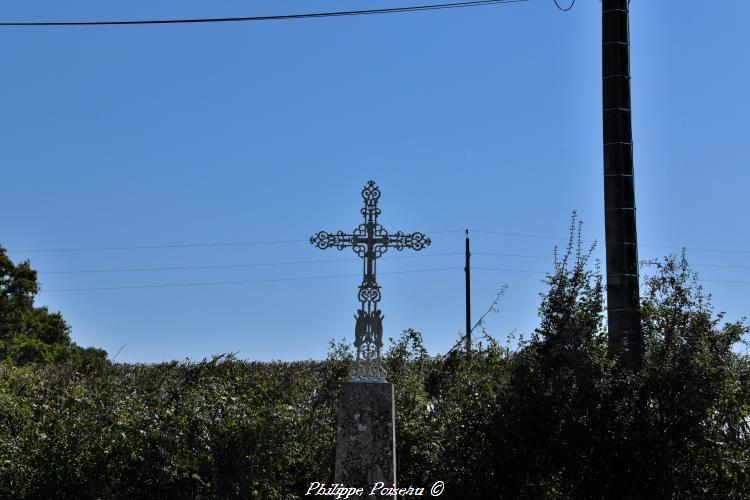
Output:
(334, 382), (396, 492)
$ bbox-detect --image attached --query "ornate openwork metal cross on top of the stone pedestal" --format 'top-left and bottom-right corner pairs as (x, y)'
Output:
(310, 181), (431, 382)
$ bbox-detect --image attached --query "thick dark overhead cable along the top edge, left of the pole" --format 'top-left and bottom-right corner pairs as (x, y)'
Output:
(0, 0), (528, 27)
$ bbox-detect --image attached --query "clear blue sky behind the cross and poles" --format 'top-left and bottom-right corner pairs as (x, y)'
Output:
(0, 0), (750, 362)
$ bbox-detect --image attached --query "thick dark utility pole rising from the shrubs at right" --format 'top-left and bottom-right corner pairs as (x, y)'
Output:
(602, 0), (643, 371)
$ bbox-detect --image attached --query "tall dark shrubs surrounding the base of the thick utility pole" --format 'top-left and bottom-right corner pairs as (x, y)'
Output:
(492, 217), (750, 499)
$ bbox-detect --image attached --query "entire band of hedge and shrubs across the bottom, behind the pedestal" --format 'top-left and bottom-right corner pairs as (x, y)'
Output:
(0, 232), (750, 499)
